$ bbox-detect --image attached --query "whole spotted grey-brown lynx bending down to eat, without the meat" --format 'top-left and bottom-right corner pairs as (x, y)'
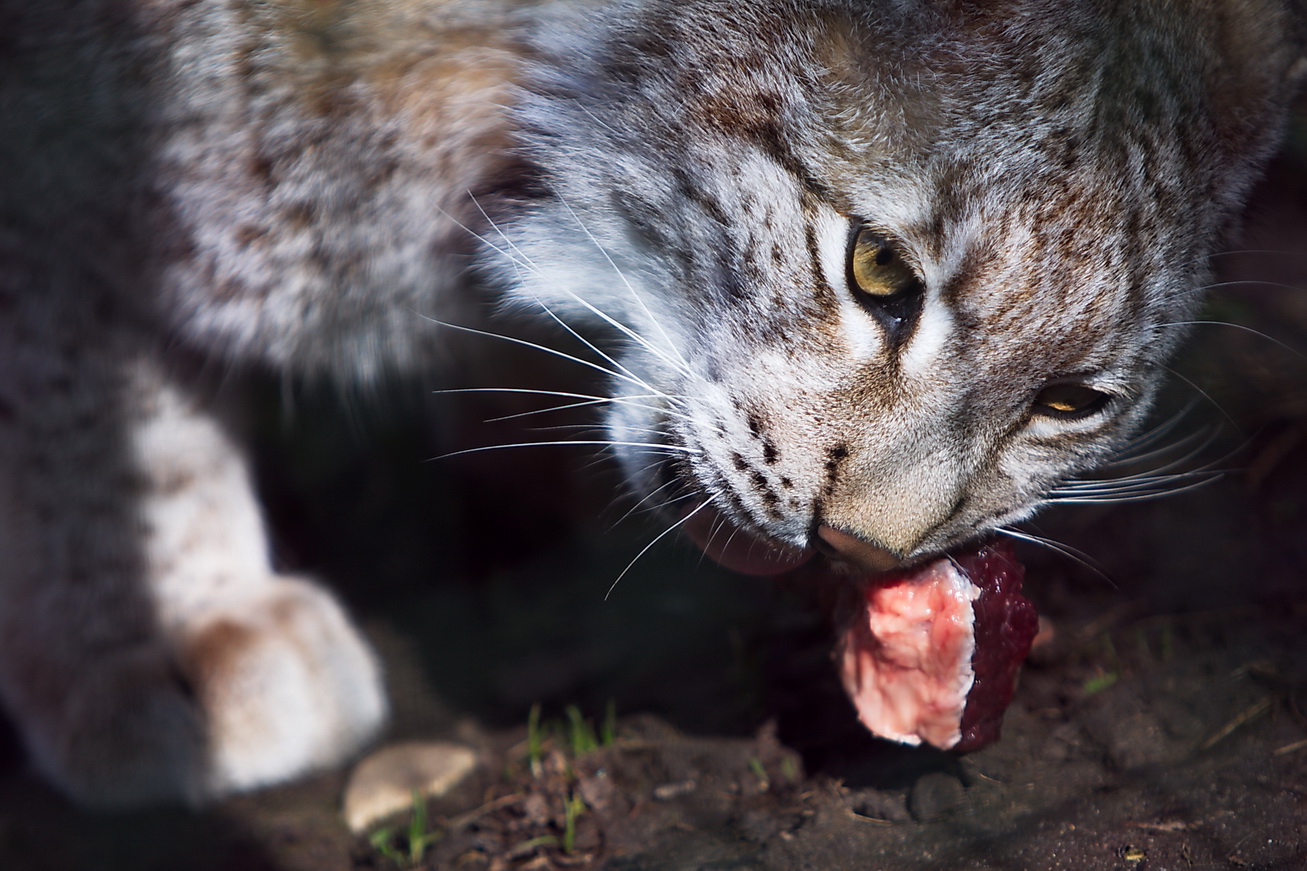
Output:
(0, 0), (1303, 806)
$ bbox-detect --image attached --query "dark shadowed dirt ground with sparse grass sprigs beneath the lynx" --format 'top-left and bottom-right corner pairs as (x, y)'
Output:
(0, 106), (1307, 871)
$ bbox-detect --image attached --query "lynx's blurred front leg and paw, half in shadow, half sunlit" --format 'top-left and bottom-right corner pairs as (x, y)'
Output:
(0, 342), (386, 804)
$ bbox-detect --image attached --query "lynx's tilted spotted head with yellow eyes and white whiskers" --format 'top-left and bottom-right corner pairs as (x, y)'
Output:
(501, 0), (1293, 568)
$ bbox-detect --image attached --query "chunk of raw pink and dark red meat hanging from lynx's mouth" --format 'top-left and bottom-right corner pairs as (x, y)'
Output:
(838, 543), (1038, 751)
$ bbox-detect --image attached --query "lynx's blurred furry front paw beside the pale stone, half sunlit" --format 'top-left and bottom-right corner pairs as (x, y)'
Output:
(33, 579), (387, 806)
